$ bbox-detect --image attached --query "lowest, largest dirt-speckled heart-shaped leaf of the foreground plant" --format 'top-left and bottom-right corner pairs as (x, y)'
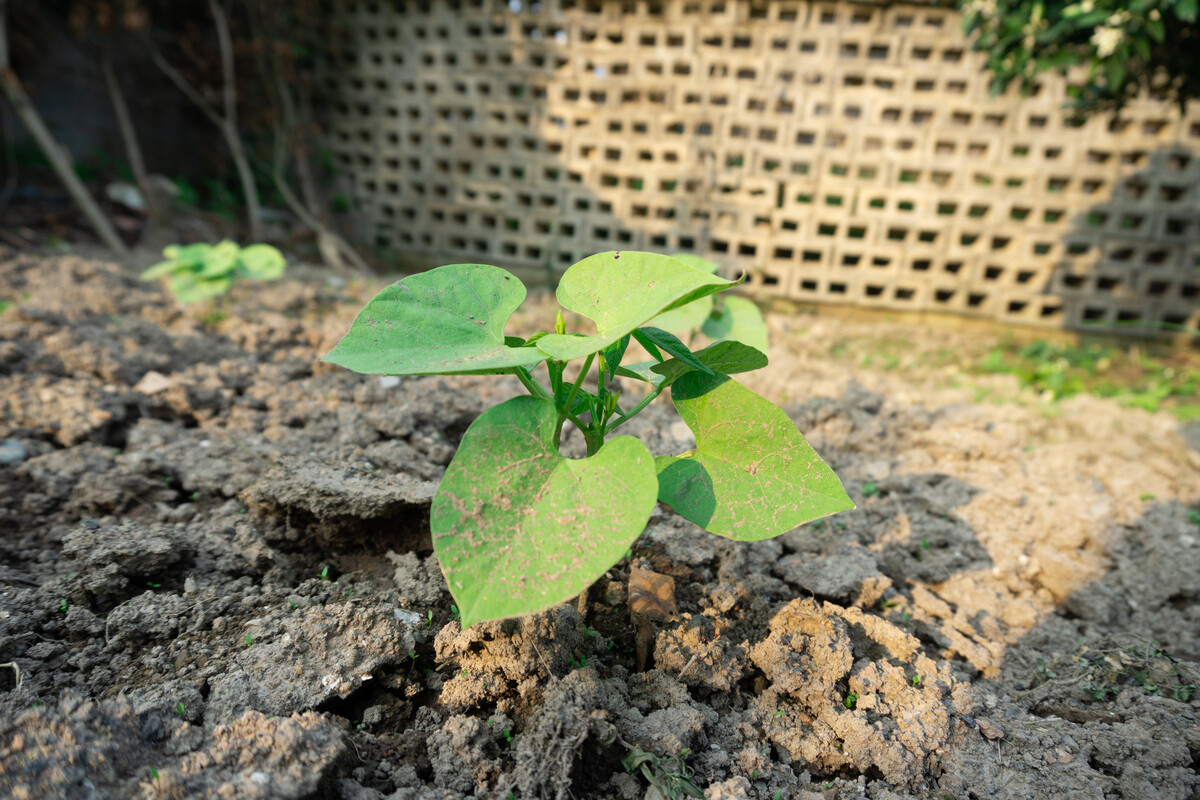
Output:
(430, 397), (658, 627)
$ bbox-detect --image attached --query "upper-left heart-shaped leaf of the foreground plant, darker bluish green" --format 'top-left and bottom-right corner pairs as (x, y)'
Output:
(323, 264), (546, 375)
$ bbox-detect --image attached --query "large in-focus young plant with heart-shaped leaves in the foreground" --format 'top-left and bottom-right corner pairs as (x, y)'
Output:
(324, 251), (854, 628)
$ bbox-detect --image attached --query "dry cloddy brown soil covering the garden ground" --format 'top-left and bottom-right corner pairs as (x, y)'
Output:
(0, 255), (1200, 800)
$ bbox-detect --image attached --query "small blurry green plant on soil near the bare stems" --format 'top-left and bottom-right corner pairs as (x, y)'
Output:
(142, 240), (287, 306)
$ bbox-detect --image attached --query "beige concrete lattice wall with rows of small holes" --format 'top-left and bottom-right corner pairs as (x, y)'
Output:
(328, 0), (1200, 327)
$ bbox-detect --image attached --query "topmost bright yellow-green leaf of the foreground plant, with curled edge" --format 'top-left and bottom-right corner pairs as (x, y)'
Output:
(538, 251), (737, 361)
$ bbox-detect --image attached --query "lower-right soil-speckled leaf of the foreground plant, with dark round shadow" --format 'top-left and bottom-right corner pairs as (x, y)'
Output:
(654, 372), (854, 541)
